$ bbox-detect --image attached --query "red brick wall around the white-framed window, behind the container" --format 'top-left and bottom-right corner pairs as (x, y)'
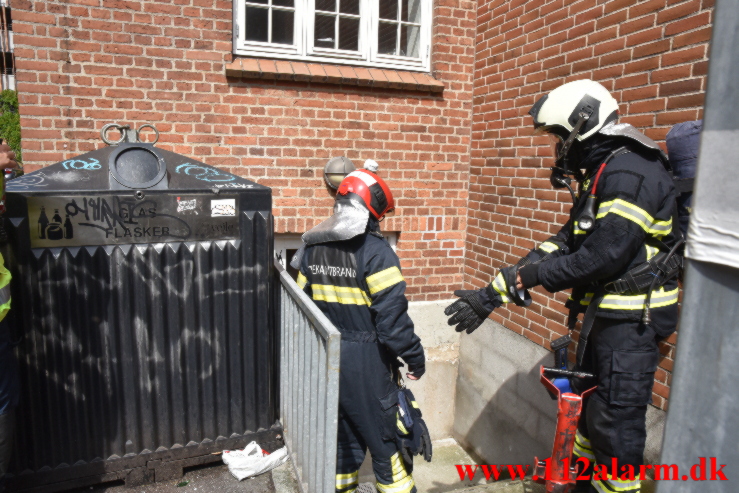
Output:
(11, 0), (475, 300)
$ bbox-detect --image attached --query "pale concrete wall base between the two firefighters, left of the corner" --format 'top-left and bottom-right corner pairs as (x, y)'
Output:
(406, 300), (460, 440)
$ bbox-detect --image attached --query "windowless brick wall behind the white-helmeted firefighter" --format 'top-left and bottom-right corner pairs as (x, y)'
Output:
(465, 0), (713, 409)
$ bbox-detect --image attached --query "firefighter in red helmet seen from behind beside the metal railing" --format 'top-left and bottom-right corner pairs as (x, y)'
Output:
(291, 161), (431, 493)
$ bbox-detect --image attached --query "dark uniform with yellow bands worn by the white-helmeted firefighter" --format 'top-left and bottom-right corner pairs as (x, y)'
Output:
(516, 140), (678, 492)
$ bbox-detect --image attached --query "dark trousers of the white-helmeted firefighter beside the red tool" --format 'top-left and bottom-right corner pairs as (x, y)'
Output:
(574, 317), (659, 493)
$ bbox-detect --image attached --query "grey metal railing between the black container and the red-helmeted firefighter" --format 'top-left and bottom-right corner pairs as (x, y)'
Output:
(275, 261), (341, 493)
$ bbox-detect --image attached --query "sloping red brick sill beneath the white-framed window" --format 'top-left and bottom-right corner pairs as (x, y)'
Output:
(226, 57), (444, 92)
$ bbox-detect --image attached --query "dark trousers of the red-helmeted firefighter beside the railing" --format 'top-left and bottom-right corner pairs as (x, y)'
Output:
(336, 334), (416, 493)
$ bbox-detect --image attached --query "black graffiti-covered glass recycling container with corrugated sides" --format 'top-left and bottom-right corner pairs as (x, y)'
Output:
(2, 127), (281, 491)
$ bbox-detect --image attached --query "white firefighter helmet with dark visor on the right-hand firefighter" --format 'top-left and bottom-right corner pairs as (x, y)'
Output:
(529, 80), (618, 141)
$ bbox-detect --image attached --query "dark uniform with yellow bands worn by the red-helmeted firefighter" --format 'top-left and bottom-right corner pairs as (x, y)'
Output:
(298, 233), (425, 493)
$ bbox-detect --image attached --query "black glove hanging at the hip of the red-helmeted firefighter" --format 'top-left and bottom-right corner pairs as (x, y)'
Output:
(396, 388), (433, 471)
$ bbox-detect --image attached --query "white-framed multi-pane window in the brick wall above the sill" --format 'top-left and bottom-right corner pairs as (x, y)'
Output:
(234, 0), (432, 72)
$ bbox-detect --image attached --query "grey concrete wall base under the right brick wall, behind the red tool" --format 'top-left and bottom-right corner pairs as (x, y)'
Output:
(453, 320), (665, 464)
